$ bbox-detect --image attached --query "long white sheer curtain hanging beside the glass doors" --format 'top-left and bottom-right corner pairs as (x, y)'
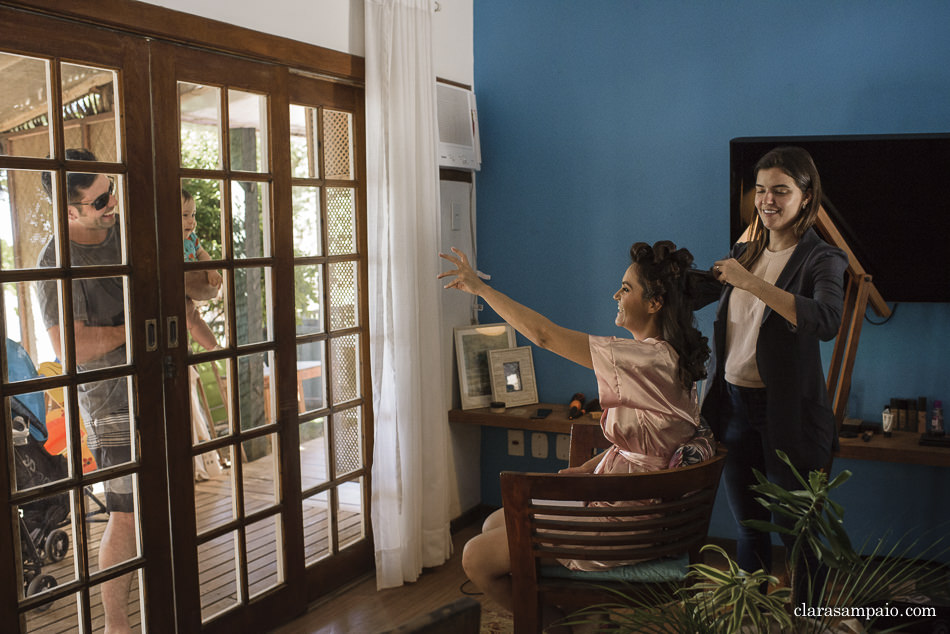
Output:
(365, 0), (452, 589)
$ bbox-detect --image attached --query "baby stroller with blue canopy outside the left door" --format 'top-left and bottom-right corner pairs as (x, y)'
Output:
(7, 339), (70, 596)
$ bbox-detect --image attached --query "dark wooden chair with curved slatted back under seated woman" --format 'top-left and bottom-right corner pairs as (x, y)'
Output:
(501, 424), (726, 634)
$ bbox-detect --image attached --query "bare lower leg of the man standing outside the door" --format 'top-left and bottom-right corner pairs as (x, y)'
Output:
(99, 511), (136, 634)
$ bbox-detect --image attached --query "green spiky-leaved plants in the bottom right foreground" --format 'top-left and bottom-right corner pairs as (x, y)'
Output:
(562, 451), (947, 634)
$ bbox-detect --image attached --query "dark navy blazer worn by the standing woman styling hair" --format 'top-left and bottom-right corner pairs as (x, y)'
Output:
(696, 229), (848, 473)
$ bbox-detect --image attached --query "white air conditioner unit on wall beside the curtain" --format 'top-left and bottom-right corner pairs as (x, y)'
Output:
(436, 83), (482, 170)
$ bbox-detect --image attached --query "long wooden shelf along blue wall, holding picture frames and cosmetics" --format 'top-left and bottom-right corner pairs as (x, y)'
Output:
(449, 403), (950, 467)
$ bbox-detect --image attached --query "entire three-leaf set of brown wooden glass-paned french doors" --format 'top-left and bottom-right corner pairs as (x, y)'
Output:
(0, 9), (373, 632)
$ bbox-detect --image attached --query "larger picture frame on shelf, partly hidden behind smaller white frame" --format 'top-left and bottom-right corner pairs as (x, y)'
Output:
(455, 324), (515, 409)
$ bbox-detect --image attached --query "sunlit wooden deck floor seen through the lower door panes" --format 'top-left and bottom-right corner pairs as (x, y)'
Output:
(26, 438), (364, 634)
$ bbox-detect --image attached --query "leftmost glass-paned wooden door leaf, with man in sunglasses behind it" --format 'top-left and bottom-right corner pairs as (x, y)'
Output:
(0, 8), (174, 632)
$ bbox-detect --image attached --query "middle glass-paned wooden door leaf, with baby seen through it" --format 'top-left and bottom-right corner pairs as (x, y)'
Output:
(153, 45), (303, 631)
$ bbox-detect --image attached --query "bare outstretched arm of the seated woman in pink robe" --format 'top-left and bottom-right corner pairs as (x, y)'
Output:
(439, 247), (594, 368)
